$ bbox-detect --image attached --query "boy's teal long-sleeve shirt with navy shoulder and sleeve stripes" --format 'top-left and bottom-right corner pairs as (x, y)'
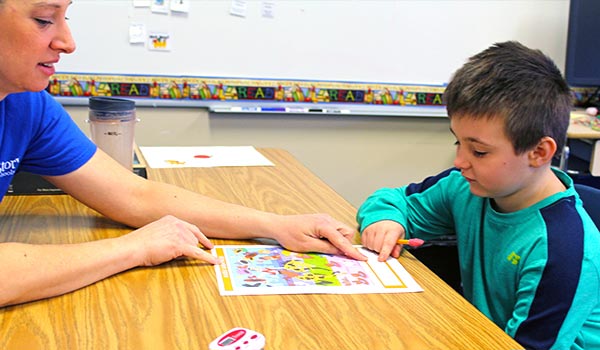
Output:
(357, 169), (600, 349)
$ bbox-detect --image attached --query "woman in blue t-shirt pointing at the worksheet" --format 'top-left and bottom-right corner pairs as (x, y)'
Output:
(0, 0), (366, 306)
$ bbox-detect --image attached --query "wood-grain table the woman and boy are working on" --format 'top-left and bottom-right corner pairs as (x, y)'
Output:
(0, 149), (521, 350)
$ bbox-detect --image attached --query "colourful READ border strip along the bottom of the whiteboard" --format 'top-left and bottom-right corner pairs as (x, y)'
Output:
(47, 73), (444, 106)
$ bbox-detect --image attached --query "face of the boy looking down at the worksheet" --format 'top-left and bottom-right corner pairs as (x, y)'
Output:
(450, 116), (533, 201)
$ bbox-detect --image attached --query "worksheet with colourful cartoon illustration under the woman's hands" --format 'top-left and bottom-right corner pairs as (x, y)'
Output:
(212, 245), (423, 295)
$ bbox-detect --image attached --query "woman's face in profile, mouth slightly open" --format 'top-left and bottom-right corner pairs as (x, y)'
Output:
(0, 0), (75, 99)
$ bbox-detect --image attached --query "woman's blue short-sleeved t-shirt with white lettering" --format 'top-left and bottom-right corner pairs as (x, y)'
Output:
(0, 91), (96, 199)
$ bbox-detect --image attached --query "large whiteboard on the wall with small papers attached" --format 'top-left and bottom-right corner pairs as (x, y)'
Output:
(57, 0), (569, 84)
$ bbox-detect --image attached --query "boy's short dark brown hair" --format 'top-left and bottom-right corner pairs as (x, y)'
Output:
(444, 41), (573, 154)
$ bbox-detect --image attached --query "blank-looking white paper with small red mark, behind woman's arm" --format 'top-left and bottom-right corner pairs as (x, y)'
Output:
(140, 146), (274, 168)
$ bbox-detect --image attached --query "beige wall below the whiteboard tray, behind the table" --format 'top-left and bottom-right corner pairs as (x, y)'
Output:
(67, 106), (455, 207)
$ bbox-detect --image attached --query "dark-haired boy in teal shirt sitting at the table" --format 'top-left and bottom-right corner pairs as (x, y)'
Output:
(358, 42), (600, 349)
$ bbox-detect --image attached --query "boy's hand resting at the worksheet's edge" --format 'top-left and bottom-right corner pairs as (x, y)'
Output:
(361, 220), (406, 261)
